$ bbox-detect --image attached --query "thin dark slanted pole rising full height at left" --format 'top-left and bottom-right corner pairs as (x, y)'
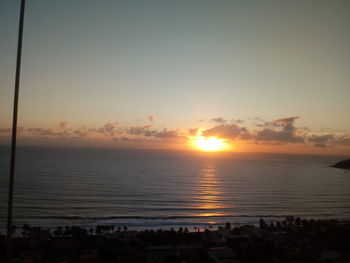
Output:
(7, 0), (25, 263)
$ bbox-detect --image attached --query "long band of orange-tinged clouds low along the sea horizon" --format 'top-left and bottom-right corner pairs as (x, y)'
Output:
(0, 115), (350, 151)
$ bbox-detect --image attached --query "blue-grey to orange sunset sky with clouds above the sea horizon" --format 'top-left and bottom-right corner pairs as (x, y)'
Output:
(0, 0), (350, 154)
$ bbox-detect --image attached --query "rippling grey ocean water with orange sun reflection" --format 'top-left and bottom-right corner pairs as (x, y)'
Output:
(0, 146), (350, 232)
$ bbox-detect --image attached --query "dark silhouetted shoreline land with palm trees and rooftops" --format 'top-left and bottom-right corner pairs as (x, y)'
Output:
(0, 217), (350, 263)
